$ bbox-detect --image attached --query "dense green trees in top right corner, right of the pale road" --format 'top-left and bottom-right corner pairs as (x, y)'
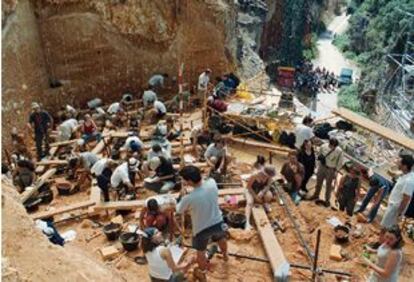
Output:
(334, 0), (414, 91)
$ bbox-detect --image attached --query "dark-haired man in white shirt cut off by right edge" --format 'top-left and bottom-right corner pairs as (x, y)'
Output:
(381, 155), (414, 228)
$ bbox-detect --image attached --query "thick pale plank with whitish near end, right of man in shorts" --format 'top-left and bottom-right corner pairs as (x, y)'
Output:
(252, 207), (290, 281)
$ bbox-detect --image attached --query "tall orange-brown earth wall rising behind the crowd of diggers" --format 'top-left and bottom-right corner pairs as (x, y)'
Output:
(2, 0), (237, 149)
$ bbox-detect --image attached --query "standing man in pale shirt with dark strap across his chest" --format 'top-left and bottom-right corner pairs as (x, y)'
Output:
(309, 138), (344, 207)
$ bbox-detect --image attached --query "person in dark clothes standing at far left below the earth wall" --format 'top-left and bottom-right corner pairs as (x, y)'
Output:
(27, 103), (53, 161)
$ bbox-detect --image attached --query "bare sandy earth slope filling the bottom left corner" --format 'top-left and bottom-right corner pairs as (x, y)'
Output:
(2, 183), (125, 282)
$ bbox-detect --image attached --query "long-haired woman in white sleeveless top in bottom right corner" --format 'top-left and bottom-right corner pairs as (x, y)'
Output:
(360, 226), (404, 282)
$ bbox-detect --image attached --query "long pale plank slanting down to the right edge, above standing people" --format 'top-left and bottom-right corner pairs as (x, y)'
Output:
(332, 108), (414, 151)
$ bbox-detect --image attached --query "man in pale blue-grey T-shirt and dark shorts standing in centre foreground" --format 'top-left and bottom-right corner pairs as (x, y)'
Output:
(176, 165), (228, 278)
